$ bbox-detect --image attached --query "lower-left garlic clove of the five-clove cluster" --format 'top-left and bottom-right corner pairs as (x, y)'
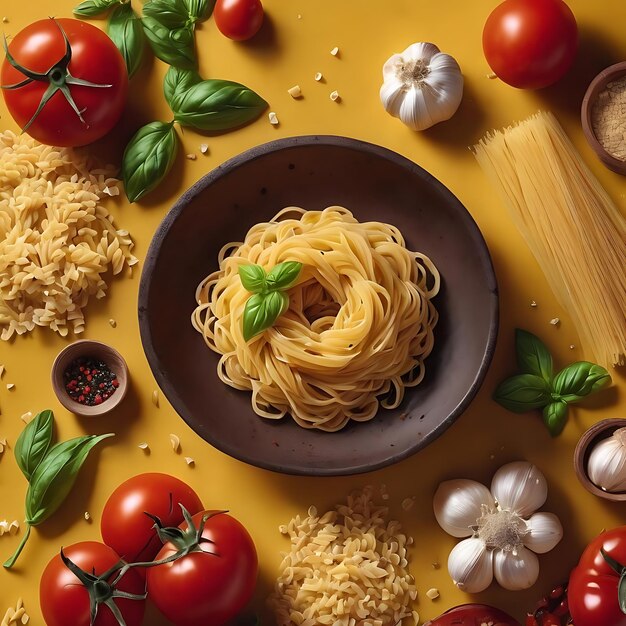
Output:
(448, 537), (493, 593)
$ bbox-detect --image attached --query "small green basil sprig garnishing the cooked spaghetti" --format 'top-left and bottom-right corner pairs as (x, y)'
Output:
(239, 261), (302, 341)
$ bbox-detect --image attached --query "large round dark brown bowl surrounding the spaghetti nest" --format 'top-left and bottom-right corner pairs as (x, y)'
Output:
(139, 136), (498, 475)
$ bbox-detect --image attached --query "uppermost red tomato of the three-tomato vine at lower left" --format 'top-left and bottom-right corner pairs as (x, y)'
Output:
(100, 473), (204, 563)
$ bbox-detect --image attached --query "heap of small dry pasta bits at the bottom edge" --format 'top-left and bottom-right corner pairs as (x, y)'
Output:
(269, 487), (419, 626)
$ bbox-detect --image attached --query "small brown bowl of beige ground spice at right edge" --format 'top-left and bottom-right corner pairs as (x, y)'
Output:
(581, 61), (626, 174)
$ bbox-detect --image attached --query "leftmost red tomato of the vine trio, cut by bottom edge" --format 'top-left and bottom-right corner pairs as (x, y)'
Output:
(39, 541), (145, 626)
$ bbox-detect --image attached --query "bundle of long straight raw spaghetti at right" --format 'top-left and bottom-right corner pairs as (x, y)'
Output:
(474, 112), (626, 367)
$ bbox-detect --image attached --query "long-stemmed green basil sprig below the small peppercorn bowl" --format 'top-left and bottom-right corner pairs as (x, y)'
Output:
(4, 410), (113, 569)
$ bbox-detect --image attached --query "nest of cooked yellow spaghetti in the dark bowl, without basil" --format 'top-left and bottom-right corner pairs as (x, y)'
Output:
(192, 206), (440, 431)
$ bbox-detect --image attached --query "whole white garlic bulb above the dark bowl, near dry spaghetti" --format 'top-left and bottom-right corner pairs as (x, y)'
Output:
(380, 43), (463, 130)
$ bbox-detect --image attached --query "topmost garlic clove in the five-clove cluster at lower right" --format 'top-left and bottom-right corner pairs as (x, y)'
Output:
(491, 461), (548, 517)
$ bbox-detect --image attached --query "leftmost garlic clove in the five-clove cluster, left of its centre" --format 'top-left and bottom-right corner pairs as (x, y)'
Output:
(433, 478), (495, 537)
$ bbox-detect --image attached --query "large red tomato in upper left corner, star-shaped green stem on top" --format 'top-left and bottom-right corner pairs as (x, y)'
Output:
(0, 18), (128, 146)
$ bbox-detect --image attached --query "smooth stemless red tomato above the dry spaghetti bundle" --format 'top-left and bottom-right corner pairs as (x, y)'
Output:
(483, 0), (578, 89)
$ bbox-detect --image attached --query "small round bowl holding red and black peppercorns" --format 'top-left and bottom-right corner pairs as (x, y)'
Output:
(52, 339), (128, 416)
